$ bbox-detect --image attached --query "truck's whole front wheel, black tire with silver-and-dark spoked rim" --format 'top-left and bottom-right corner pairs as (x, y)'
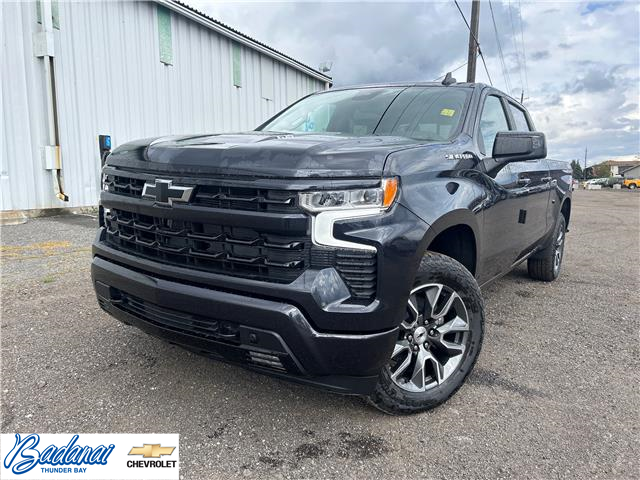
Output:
(369, 252), (484, 415)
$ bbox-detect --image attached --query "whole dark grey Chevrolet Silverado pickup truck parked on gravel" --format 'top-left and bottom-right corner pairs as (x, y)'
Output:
(91, 80), (572, 414)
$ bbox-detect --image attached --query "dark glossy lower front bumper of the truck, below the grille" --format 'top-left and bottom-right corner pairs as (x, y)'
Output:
(92, 258), (397, 394)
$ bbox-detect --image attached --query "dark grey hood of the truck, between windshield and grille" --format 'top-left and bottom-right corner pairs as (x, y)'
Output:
(108, 131), (423, 178)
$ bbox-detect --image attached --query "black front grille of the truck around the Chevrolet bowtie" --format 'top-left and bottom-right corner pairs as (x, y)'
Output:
(104, 168), (377, 303)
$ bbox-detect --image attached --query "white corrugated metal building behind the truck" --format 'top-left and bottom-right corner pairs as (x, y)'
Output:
(0, 0), (331, 211)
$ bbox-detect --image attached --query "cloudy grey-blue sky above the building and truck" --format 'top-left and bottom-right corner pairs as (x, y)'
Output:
(189, 0), (640, 164)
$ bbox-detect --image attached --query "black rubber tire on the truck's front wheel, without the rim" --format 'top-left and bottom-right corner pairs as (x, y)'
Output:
(368, 252), (484, 415)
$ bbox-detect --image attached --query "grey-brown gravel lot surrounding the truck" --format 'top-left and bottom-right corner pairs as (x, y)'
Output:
(1, 191), (640, 479)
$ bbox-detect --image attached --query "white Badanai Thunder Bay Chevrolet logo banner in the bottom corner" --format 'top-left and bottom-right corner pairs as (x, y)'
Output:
(0, 433), (180, 480)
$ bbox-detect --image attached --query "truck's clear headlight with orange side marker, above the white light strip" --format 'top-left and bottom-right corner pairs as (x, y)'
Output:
(300, 177), (398, 213)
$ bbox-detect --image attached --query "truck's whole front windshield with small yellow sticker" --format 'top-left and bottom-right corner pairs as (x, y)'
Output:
(260, 87), (469, 140)
